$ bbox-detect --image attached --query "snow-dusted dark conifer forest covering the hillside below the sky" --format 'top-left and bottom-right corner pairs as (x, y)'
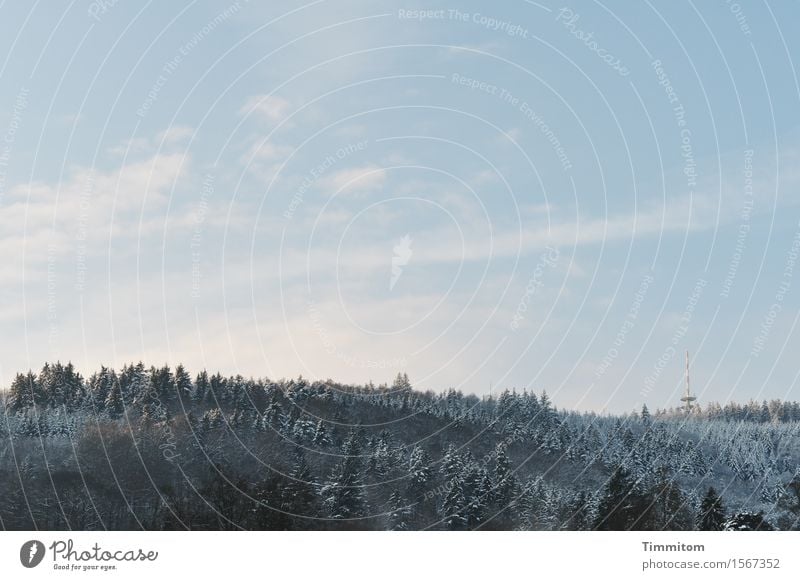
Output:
(0, 363), (800, 530)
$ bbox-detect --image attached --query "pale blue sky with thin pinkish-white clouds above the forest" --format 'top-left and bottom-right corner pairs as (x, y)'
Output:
(0, 0), (800, 412)
